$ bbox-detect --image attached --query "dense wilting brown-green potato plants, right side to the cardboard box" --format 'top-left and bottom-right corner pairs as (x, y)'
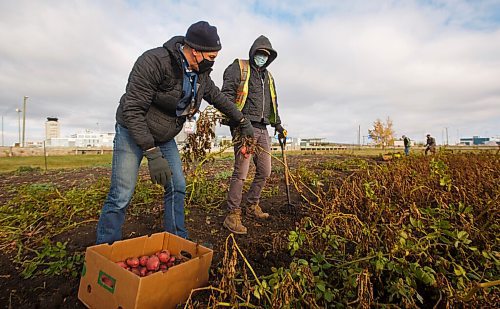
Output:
(197, 153), (500, 308)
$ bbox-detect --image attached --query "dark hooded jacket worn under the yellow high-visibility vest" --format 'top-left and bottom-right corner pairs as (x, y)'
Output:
(221, 35), (281, 126)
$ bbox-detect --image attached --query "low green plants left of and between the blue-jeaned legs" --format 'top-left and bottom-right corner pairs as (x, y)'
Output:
(0, 177), (163, 278)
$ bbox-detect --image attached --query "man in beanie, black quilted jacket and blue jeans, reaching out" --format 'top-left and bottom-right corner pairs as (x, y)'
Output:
(96, 21), (253, 244)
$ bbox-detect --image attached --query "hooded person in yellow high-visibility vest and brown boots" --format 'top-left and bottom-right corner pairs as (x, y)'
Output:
(222, 35), (287, 234)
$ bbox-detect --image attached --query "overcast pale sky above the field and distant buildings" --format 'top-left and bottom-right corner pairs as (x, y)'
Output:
(0, 0), (500, 145)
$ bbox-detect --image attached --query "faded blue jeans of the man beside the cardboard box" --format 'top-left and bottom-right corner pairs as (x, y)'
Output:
(96, 124), (188, 244)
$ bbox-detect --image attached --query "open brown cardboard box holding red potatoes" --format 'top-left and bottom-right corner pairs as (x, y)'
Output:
(78, 233), (213, 309)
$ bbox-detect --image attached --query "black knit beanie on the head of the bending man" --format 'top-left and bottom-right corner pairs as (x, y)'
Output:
(184, 21), (222, 51)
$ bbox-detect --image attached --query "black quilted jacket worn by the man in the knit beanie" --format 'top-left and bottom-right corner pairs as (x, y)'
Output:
(116, 36), (243, 150)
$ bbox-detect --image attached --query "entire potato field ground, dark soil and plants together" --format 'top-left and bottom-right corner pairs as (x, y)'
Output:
(0, 152), (500, 309)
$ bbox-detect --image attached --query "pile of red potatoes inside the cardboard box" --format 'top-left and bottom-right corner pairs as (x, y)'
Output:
(116, 250), (189, 277)
